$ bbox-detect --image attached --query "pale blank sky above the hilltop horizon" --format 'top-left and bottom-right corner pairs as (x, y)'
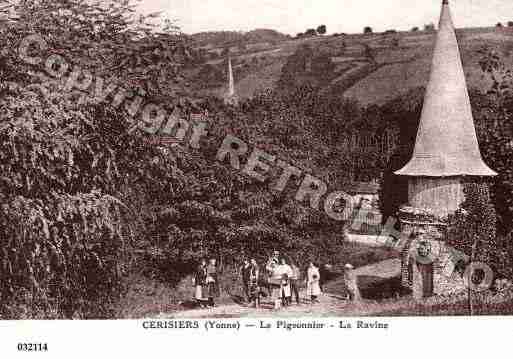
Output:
(140, 0), (513, 35)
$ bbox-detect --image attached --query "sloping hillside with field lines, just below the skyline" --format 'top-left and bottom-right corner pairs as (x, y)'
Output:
(191, 28), (513, 105)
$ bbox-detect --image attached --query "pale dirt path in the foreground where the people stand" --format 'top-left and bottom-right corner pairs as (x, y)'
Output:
(157, 259), (400, 319)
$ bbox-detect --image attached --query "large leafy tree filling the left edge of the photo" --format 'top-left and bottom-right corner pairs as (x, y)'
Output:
(0, 0), (189, 318)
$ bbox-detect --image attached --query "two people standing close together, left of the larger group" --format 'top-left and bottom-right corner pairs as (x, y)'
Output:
(193, 258), (219, 308)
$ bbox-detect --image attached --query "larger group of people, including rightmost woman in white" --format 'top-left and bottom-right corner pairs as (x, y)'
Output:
(241, 251), (321, 309)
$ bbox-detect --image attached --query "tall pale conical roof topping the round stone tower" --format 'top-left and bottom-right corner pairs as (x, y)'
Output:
(395, 0), (497, 177)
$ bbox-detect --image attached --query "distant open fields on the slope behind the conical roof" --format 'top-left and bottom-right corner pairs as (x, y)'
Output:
(199, 27), (513, 105)
